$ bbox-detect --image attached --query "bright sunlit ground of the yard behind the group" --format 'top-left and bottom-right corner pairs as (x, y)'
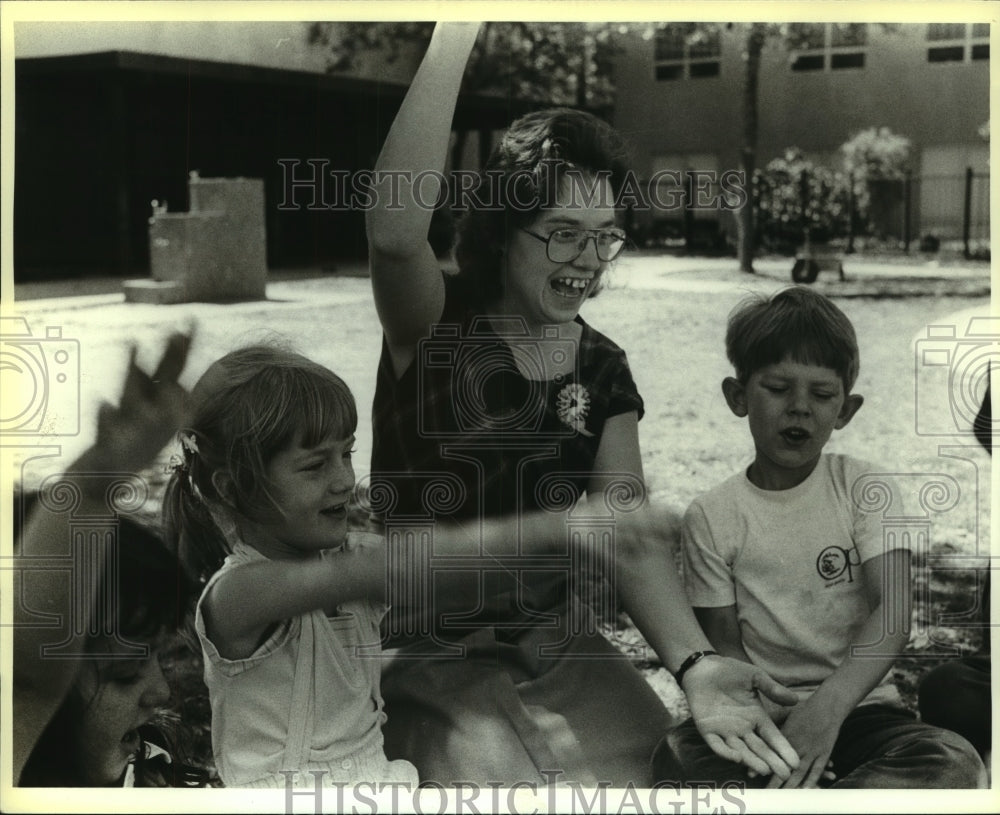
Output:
(5, 256), (1000, 732)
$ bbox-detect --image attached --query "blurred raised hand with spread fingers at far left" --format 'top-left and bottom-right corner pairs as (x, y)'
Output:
(87, 334), (191, 472)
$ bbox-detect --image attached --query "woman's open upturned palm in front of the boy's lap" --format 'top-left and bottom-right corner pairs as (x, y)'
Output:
(683, 657), (799, 779)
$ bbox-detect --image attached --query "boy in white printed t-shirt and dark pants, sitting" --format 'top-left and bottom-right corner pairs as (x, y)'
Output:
(654, 287), (985, 788)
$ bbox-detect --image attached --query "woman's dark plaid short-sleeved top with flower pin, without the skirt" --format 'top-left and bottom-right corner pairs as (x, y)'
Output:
(372, 277), (643, 519)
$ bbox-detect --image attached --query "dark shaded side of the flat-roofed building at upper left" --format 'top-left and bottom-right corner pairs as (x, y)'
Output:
(14, 51), (532, 281)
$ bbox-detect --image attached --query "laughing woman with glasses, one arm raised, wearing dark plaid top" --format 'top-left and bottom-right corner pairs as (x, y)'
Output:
(366, 24), (795, 787)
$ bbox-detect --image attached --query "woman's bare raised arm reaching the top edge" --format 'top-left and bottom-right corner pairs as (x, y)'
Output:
(366, 23), (479, 375)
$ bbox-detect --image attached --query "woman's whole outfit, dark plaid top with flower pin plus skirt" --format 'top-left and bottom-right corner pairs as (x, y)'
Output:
(370, 277), (668, 785)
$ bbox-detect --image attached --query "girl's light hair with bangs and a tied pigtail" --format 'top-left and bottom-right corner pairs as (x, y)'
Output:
(163, 345), (358, 582)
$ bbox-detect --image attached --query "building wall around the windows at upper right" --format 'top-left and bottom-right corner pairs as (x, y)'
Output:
(614, 24), (990, 245)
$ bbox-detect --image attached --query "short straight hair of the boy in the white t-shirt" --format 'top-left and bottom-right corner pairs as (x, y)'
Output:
(726, 286), (860, 394)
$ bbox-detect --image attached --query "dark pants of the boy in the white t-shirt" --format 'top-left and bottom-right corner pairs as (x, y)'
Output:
(653, 704), (986, 789)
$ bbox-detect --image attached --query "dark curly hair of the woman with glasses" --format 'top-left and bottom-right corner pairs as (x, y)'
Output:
(455, 108), (627, 306)
